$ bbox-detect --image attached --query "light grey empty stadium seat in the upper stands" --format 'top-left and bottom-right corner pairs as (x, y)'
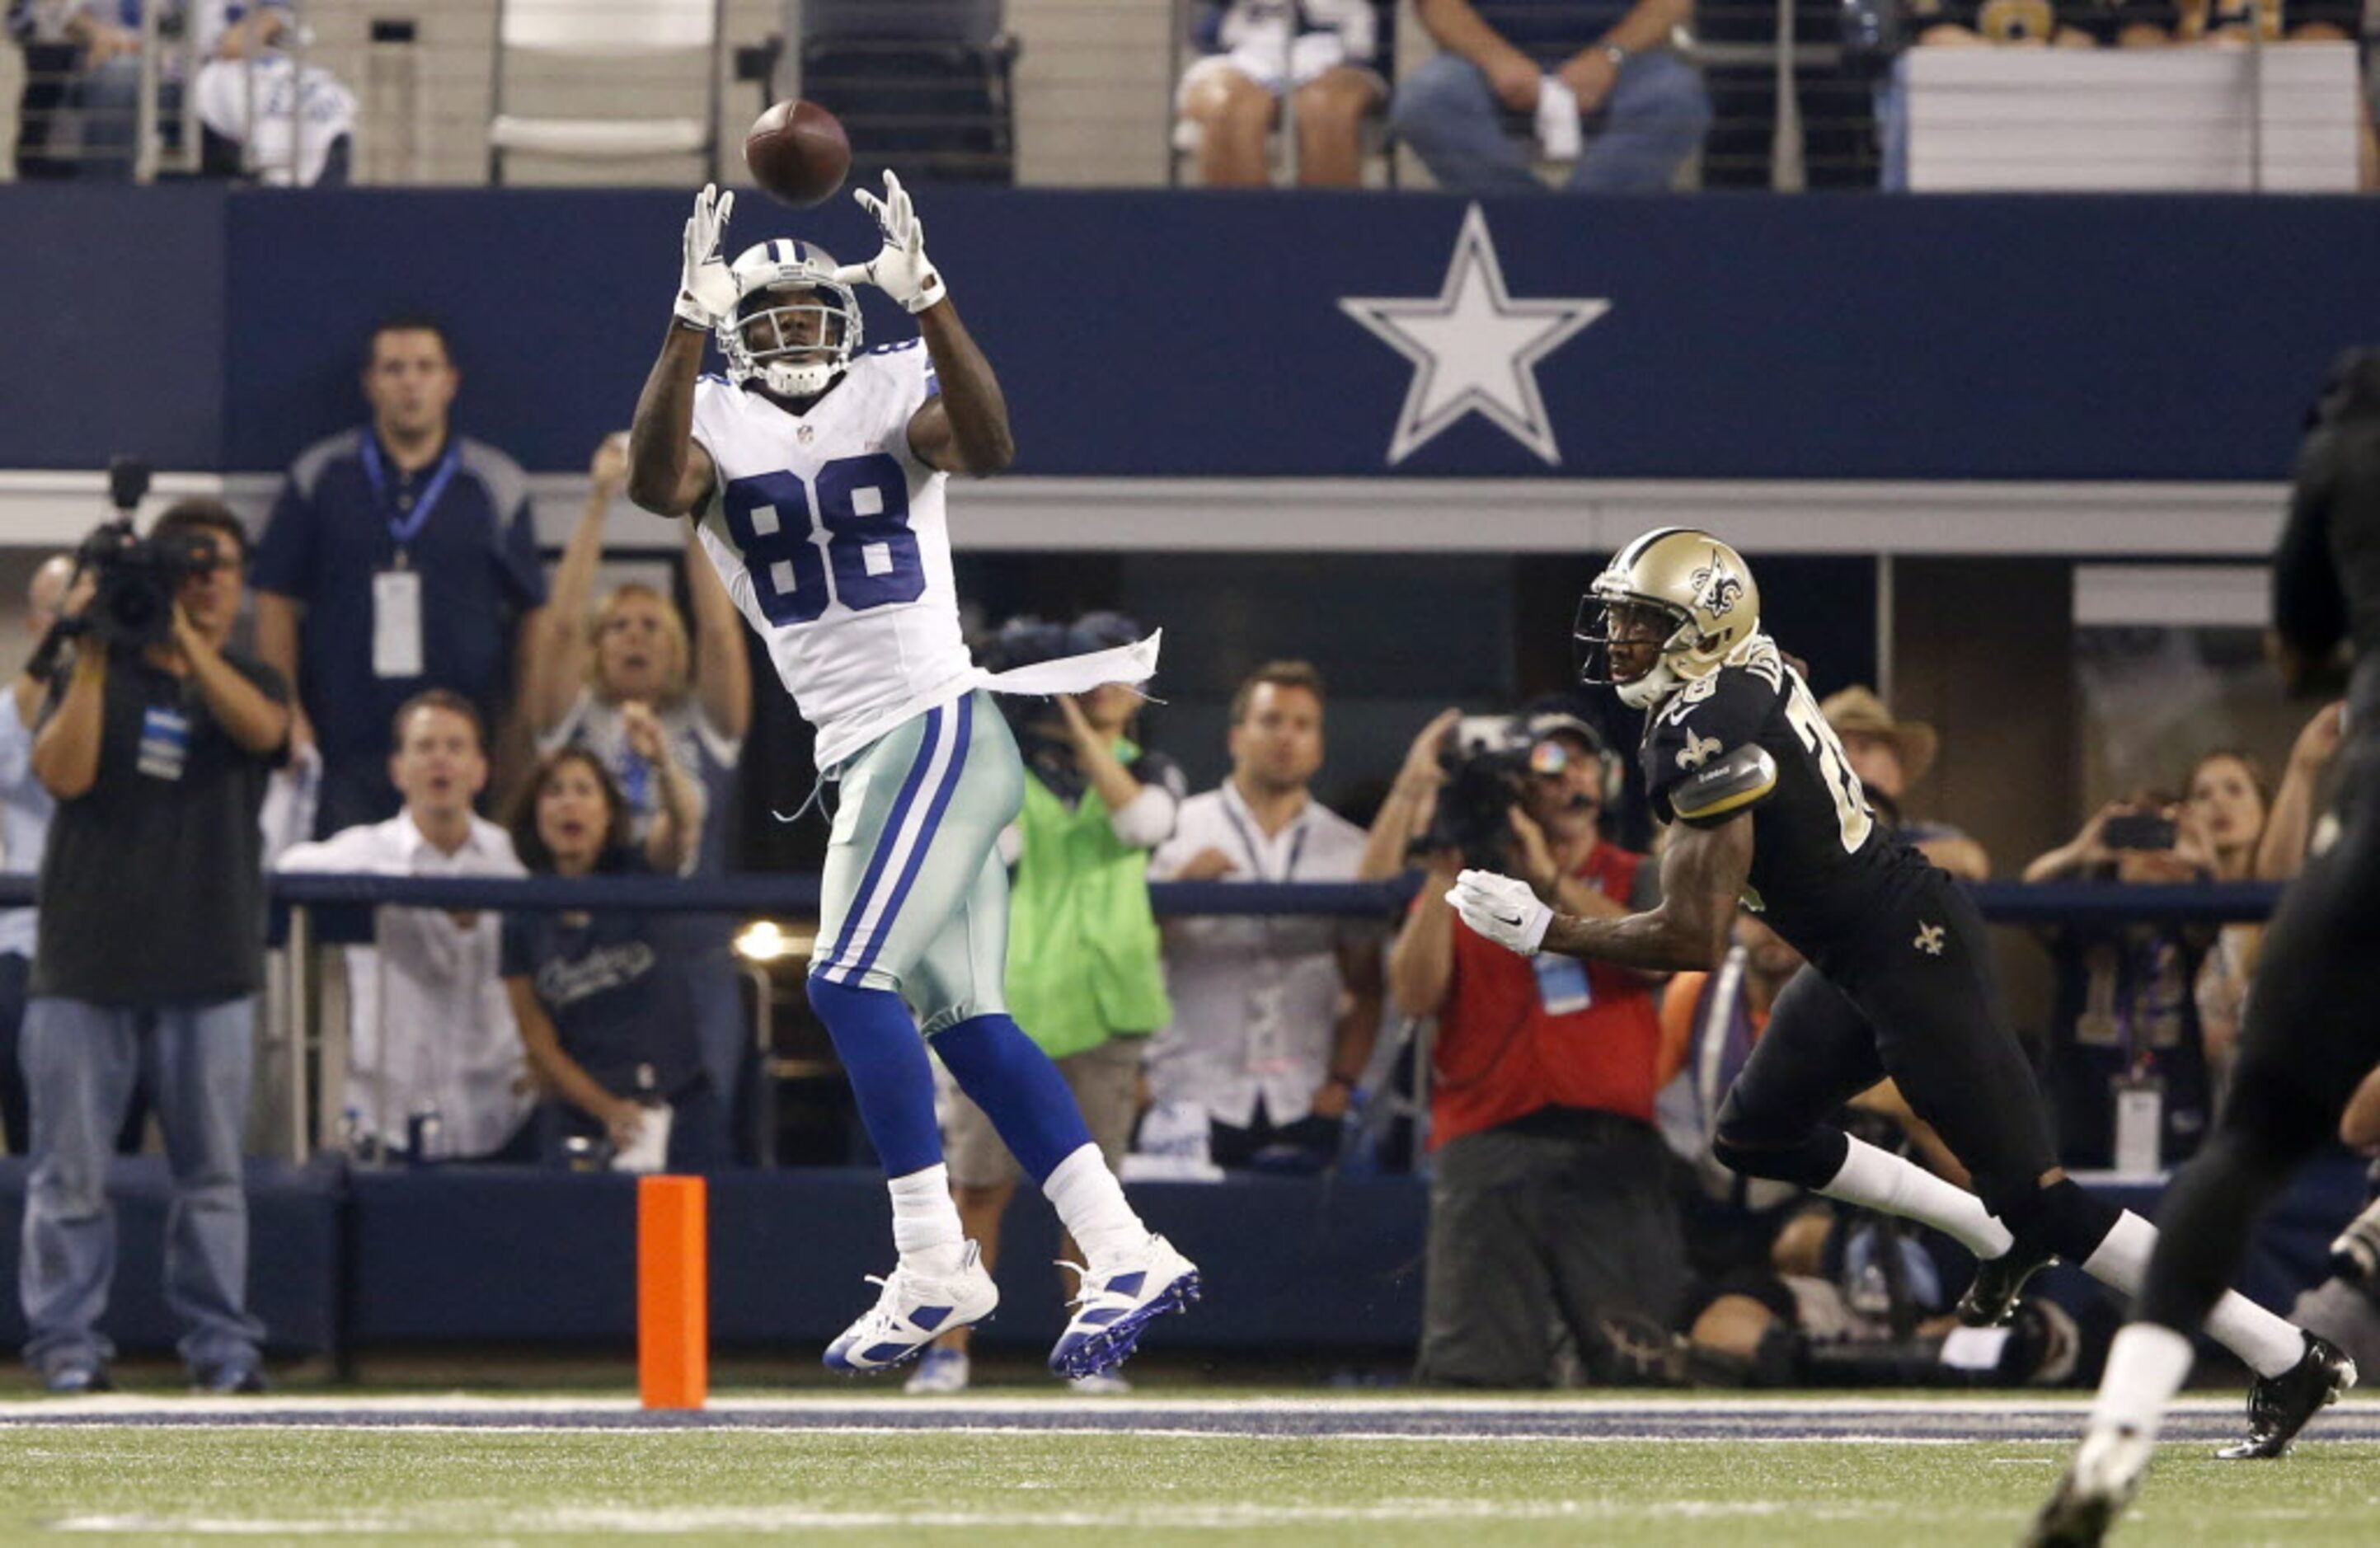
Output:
(488, 0), (724, 183)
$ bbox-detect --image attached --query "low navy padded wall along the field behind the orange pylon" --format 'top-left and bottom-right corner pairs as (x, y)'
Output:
(0, 1153), (2364, 1353)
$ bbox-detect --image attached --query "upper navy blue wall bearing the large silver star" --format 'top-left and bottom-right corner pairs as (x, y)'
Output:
(0, 185), (2380, 481)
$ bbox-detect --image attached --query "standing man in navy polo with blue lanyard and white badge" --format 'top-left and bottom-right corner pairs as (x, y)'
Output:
(255, 317), (545, 837)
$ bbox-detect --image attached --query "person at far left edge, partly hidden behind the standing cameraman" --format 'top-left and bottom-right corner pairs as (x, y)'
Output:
(0, 554), (73, 1156)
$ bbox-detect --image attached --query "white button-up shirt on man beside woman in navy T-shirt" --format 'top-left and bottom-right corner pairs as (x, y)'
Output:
(279, 811), (531, 1158)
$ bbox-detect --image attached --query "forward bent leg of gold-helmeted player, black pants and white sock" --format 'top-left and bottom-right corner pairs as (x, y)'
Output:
(1711, 968), (2009, 1258)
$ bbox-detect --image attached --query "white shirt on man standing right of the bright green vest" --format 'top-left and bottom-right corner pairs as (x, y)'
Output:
(1148, 780), (1378, 1129)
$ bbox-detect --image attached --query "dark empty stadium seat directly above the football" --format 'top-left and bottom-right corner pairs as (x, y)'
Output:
(800, 0), (1019, 183)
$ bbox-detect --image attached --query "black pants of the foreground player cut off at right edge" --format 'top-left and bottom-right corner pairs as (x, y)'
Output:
(2138, 733), (2380, 1330)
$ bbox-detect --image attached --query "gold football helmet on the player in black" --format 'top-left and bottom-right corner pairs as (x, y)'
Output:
(1570, 528), (1761, 709)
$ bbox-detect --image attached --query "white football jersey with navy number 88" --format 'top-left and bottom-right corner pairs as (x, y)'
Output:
(692, 338), (983, 771)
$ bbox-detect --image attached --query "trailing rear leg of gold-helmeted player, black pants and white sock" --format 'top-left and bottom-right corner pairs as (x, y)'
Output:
(1859, 877), (2304, 1377)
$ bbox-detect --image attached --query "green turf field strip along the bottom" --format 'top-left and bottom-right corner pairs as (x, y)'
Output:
(0, 1424), (2380, 1548)
